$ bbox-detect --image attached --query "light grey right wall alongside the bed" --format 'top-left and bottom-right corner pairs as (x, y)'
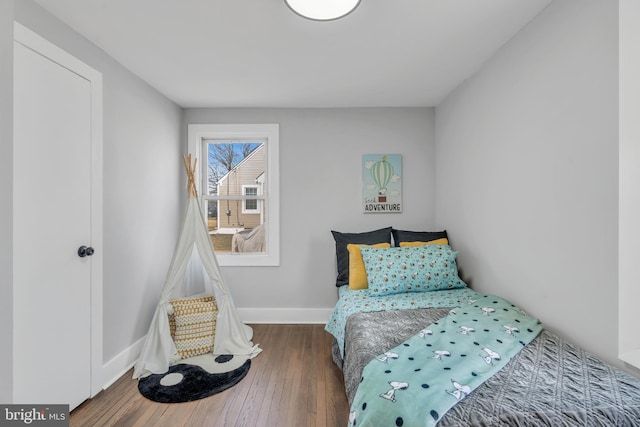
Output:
(436, 0), (619, 364)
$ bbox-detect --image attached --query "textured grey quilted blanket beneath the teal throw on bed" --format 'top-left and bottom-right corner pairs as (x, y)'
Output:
(334, 309), (640, 427)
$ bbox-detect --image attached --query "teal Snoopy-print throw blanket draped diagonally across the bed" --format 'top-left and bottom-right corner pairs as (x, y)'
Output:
(349, 291), (543, 426)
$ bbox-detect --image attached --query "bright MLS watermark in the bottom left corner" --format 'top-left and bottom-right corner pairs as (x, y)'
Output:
(0, 405), (69, 427)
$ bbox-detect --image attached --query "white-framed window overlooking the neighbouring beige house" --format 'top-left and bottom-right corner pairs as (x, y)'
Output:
(189, 124), (279, 266)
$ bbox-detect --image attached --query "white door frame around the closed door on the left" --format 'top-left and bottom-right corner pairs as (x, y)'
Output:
(13, 21), (105, 397)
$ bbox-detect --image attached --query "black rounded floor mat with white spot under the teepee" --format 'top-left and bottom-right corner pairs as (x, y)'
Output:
(138, 355), (251, 403)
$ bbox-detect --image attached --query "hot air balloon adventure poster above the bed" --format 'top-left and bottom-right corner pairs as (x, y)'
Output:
(362, 154), (402, 213)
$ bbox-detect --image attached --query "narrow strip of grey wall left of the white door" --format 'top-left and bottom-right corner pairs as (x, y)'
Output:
(0, 0), (14, 402)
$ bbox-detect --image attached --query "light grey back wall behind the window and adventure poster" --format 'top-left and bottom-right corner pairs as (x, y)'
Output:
(183, 108), (435, 321)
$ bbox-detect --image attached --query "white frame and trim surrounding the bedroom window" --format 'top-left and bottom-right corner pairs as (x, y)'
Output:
(187, 124), (280, 266)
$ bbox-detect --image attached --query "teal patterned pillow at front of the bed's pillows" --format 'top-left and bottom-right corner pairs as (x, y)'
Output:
(360, 245), (466, 296)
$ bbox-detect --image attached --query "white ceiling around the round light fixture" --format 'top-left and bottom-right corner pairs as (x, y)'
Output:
(35, 0), (551, 108)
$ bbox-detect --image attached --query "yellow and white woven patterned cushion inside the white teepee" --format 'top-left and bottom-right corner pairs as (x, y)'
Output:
(169, 296), (218, 359)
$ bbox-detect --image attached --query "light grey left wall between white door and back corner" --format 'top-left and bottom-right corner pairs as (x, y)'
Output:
(15, 0), (183, 380)
